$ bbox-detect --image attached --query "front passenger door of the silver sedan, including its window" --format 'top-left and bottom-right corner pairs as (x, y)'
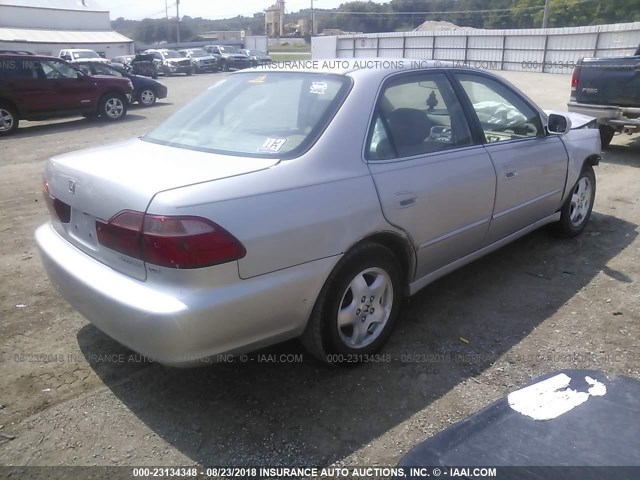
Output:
(455, 72), (568, 244)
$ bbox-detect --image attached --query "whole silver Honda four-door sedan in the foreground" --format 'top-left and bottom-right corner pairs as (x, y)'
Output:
(36, 60), (600, 366)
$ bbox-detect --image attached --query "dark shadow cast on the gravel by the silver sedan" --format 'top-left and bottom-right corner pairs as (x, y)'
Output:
(77, 212), (638, 465)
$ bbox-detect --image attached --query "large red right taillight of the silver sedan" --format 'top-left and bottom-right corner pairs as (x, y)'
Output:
(96, 210), (246, 268)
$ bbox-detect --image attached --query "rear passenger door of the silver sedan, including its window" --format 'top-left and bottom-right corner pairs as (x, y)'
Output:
(365, 72), (496, 278)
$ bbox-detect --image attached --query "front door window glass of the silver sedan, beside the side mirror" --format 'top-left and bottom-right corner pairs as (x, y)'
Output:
(456, 73), (545, 143)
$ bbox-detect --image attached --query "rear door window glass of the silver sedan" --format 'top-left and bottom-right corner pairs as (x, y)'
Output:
(366, 74), (471, 160)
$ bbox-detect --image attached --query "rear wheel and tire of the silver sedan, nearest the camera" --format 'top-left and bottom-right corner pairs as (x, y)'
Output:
(301, 243), (403, 365)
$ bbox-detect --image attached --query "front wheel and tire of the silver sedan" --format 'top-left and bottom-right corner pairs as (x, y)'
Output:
(556, 165), (596, 238)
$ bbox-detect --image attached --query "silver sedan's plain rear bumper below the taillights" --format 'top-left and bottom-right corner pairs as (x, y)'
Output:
(35, 223), (339, 366)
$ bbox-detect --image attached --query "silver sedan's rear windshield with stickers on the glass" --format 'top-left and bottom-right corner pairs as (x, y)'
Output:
(143, 72), (351, 158)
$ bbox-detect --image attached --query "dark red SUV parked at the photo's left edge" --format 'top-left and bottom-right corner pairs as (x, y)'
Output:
(0, 53), (133, 135)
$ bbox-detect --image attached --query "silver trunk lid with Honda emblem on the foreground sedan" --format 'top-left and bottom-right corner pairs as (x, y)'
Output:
(45, 139), (278, 280)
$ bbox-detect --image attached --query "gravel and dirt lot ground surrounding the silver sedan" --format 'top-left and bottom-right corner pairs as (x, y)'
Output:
(0, 73), (640, 465)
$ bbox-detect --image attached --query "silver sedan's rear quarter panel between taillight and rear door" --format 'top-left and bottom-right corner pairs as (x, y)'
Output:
(148, 72), (404, 278)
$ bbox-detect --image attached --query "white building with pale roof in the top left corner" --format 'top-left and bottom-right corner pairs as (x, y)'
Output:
(0, 0), (134, 58)
